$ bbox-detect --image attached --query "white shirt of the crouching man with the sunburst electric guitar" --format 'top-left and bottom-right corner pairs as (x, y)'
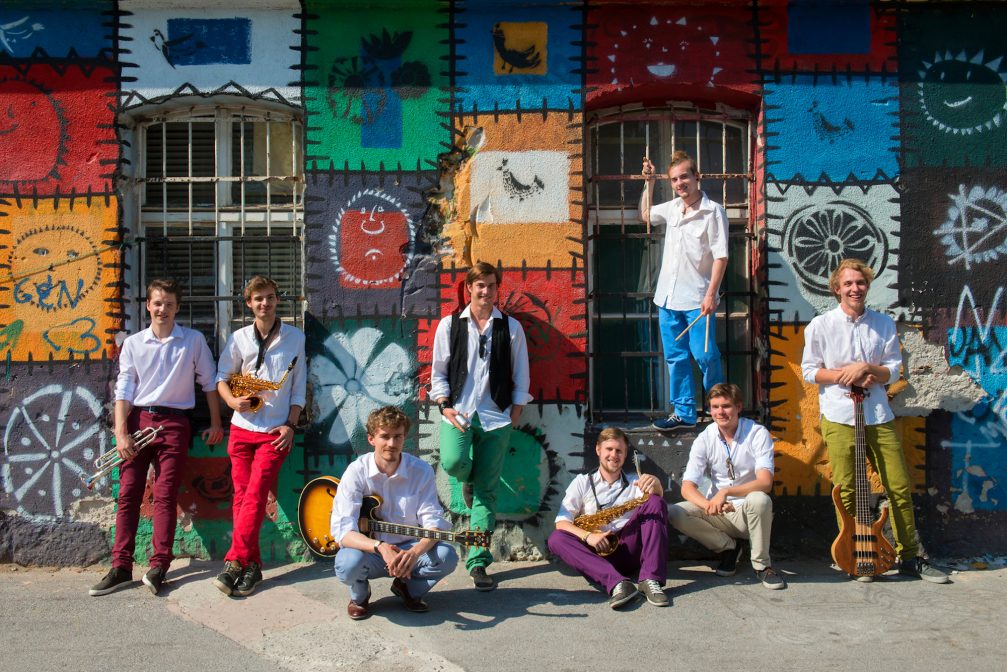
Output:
(329, 452), (451, 544)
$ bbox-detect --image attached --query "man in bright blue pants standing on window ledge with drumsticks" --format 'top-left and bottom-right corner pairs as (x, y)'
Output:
(639, 151), (727, 431)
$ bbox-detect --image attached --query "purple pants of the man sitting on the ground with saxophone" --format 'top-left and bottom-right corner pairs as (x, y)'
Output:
(549, 495), (668, 593)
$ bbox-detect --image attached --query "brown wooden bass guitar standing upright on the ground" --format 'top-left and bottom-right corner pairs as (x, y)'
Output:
(832, 385), (895, 576)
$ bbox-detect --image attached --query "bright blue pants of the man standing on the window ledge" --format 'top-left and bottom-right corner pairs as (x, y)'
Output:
(658, 306), (724, 422)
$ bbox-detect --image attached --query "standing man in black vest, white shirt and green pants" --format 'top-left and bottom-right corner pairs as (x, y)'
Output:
(430, 261), (532, 590)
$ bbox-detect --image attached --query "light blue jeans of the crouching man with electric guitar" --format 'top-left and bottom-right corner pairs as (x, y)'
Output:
(335, 539), (458, 604)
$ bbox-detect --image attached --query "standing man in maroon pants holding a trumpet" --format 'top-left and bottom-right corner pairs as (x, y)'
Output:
(89, 280), (224, 595)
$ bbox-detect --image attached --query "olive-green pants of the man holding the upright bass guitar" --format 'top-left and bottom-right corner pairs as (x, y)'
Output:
(822, 417), (919, 560)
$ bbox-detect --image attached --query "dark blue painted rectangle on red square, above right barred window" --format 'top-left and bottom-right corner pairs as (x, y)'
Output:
(786, 3), (871, 53)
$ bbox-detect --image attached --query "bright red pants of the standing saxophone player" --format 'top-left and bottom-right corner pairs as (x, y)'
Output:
(224, 425), (287, 567)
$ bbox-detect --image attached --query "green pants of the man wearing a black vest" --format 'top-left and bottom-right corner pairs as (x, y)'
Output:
(440, 414), (511, 570)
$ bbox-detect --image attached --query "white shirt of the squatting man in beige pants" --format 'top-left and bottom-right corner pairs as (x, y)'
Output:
(682, 418), (773, 501)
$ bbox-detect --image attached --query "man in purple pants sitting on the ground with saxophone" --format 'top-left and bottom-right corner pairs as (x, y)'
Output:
(549, 427), (669, 609)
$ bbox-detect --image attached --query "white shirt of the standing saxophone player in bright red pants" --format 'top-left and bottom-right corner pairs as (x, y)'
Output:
(217, 318), (307, 432)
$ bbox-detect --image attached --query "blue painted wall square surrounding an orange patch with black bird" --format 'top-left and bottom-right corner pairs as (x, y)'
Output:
(454, 3), (583, 113)
